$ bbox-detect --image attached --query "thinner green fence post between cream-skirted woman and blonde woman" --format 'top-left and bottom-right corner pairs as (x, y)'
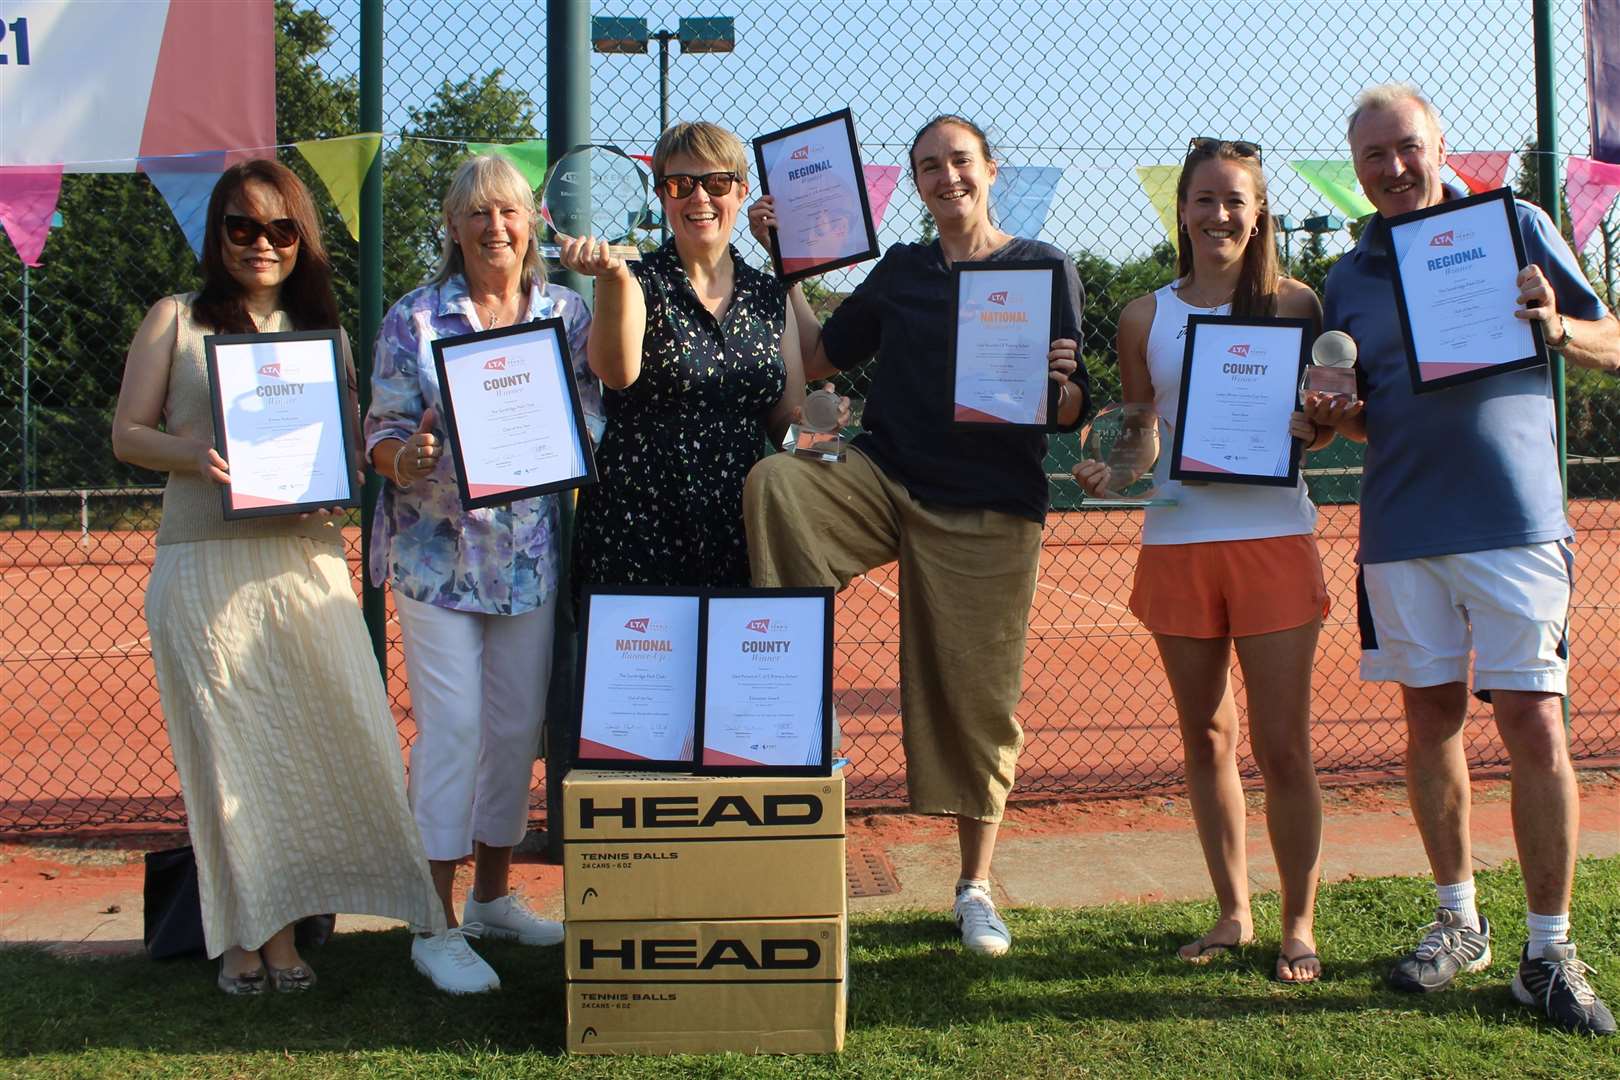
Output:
(356, 0), (389, 683)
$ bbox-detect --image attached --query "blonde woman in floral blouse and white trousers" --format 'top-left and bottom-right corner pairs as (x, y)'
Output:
(366, 155), (601, 993)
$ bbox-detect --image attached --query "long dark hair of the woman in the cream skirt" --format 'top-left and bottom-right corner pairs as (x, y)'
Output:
(193, 157), (339, 334)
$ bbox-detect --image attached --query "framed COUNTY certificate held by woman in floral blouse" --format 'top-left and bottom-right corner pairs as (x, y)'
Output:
(433, 319), (596, 510)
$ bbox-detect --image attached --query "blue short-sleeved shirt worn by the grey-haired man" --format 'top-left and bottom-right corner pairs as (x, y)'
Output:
(1324, 189), (1605, 563)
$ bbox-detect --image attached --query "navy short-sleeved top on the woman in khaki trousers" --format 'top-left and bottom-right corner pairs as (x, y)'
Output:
(821, 238), (1090, 521)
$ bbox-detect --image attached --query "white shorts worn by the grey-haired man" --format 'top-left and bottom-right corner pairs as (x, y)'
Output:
(1356, 541), (1575, 701)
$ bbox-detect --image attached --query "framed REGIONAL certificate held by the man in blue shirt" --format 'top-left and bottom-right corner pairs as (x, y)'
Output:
(1388, 189), (1547, 393)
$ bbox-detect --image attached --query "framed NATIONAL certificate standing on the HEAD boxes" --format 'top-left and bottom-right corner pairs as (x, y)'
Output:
(577, 589), (701, 769)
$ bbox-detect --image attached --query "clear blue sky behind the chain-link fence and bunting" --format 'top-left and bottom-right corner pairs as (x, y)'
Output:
(314, 0), (1588, 288)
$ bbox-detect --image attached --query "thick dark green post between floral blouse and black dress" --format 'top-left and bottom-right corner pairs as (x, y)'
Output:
(546, 0), (591, 863)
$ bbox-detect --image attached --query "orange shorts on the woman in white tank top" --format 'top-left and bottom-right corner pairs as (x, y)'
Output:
(1131, 533), (1328, 638)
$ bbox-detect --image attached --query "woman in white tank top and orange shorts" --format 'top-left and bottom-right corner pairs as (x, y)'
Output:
(1074, 139), (1333, 983)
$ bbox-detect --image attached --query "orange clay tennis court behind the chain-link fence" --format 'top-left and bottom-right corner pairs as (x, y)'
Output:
(9, 502), (1620, 829)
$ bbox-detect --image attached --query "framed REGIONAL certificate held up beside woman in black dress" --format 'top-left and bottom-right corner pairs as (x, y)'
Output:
(753, 108), (878, 282)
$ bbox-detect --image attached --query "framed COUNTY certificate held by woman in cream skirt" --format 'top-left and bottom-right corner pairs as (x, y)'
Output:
(204, 330), (358, 520)
